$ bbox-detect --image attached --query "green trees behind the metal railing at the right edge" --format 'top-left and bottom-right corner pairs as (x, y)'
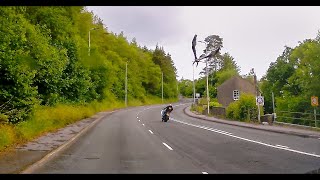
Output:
(261, 33), (320, 123)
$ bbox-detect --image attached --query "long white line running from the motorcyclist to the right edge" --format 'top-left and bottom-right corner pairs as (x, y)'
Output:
(172, 118), (320, 158)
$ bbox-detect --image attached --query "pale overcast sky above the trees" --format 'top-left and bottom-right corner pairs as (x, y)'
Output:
(87, 6), (320, 80)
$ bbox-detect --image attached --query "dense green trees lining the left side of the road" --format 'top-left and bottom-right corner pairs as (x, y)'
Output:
(0, 6), (178, 123)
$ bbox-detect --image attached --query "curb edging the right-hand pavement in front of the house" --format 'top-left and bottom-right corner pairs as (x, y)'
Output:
(183, 106), (320, 138)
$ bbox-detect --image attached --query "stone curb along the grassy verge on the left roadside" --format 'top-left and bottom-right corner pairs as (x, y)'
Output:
(19, 110), (116, 174)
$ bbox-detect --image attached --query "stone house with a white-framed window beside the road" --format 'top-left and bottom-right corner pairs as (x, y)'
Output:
(217, 75), (256, 107)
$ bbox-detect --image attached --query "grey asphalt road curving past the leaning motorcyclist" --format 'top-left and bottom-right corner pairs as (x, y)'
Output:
(33, 101), (320, 174)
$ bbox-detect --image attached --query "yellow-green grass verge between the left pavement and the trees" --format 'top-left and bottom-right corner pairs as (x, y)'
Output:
(0, 97), (178, 151)
